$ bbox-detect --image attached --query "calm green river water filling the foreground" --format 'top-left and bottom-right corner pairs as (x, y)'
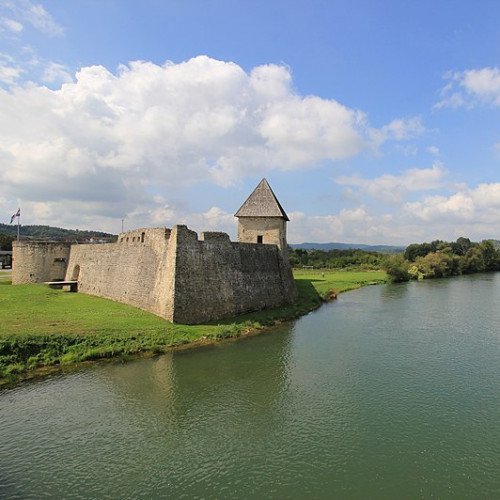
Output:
(0, 274), (500, 498)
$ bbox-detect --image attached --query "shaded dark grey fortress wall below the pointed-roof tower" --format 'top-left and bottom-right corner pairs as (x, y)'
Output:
(171, 226), (296, 323)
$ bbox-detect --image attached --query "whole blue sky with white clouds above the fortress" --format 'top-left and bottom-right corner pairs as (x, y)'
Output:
(0, 0), (500, 245)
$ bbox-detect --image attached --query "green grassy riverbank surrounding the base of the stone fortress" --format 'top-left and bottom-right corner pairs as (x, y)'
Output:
(0, 270), (387, 384)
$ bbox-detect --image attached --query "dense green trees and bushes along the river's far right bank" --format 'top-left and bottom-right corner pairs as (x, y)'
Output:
(385, 237), (500, 282)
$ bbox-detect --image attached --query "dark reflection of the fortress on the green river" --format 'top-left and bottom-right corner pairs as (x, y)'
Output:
(96, 326), (291, 419)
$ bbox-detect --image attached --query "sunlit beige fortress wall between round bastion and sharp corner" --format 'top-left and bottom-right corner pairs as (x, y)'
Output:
(66, 228), (174, 319)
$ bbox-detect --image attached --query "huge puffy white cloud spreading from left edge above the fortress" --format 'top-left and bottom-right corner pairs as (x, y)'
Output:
(0, 56), (418, 230)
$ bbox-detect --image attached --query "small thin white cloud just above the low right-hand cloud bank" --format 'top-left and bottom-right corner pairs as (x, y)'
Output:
(335, 162), (446, 202)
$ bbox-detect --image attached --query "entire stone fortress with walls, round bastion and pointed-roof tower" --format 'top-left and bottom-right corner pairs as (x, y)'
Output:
(12, 179), (297, 324)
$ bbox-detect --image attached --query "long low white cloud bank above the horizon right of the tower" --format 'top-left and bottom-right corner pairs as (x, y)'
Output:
(288, 183), (500, 245)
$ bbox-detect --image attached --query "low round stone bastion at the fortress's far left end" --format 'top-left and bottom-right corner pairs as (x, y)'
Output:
(12, 241), (71, 285)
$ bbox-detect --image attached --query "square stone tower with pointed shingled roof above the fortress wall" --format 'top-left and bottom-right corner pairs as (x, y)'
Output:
(234, 179), (290, 251)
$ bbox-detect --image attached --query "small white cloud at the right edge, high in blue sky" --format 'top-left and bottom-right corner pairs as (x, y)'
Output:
(434, 67), (500, 109)
